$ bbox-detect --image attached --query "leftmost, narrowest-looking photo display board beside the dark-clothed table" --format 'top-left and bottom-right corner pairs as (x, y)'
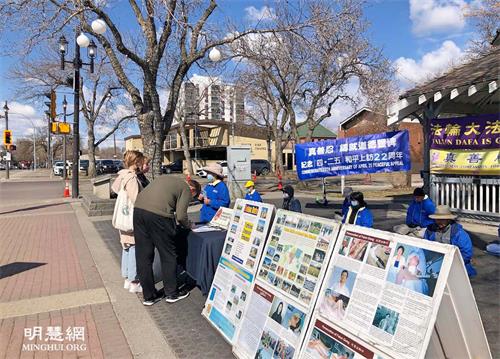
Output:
(202, 199), (274, 344)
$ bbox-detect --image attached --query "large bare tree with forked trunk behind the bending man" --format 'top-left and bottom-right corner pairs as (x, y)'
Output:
(0, 0), (300, 175)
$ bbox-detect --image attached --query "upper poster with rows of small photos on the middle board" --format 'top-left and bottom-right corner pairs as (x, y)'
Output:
(257, 209), (339, 307)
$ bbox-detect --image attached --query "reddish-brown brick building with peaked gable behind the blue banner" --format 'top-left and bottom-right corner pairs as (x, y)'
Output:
(338, 107), (424, 173)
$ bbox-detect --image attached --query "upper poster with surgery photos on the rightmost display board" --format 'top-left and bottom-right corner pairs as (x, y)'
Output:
(313, 225), (453, 358)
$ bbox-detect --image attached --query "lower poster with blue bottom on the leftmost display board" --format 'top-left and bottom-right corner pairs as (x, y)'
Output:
(202, 257), (254, 343)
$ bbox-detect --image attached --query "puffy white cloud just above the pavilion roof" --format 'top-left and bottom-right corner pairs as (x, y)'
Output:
(394, 40), (464, 87)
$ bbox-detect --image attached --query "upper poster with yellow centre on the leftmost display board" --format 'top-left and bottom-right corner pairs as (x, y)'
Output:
(222, 199), (274, 273)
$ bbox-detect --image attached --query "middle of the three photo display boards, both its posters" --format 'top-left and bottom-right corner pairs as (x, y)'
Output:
(233, 209), (340, 359)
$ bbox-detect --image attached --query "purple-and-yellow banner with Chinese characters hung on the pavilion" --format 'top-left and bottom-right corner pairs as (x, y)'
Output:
(429, 114), (500, 174)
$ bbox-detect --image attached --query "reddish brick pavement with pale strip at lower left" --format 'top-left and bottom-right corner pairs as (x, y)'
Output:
(0, 194), (132, 359)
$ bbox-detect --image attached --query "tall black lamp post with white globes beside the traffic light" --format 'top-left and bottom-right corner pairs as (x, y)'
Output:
(59, 19), (106, 198)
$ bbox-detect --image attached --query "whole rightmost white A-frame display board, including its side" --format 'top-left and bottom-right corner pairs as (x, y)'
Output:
(301, 225), (491, 359)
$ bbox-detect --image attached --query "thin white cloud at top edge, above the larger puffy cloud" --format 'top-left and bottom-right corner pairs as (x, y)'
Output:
(410, 0), (467, 36)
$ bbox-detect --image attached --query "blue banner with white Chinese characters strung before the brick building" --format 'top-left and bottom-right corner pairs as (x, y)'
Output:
(295, 131), (411, 180)
